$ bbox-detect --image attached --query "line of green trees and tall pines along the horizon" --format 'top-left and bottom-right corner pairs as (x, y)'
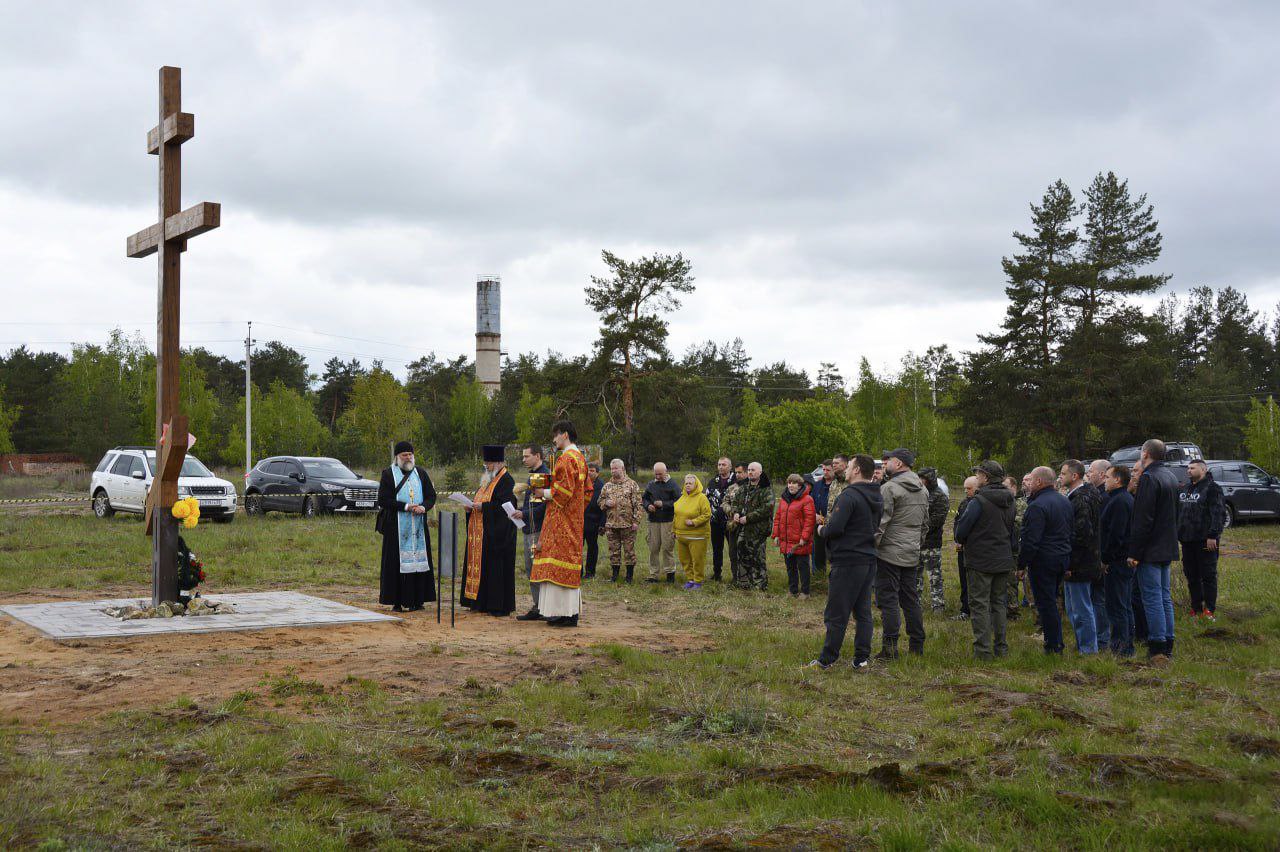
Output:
(0, 173), (1280, 477)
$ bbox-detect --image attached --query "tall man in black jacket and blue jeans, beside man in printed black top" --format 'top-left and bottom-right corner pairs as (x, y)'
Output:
(1129, 438), (1179, 660)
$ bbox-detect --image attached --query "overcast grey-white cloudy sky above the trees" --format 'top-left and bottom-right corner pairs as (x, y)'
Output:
(0, 0), (1280, 377)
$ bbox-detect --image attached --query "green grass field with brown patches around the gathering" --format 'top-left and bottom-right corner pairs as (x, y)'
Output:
(0, 493), (1280, 849)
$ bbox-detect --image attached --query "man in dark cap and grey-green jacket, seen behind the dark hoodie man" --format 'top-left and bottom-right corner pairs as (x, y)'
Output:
(876, 446), (929, 652)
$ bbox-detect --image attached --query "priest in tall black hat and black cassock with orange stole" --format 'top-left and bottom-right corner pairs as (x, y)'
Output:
(462, 444), (516, 617)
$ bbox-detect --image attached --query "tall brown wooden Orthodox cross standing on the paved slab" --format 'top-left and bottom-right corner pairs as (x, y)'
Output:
(125, 65), (221, 604)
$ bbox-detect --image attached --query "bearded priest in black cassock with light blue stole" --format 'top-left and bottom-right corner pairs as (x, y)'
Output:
(374, 441), (435, 613)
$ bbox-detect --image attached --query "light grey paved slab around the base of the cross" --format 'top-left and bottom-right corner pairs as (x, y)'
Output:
(0, 591), (399, 641)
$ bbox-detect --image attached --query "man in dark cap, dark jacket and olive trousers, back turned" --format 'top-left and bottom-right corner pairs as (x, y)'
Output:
(955, 459), (1018, 660)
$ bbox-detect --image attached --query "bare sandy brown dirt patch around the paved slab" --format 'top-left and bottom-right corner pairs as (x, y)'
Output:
(0, 587), (707, 724)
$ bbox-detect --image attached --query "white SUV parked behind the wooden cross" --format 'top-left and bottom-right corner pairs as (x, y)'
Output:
(88, 446), (236, 523)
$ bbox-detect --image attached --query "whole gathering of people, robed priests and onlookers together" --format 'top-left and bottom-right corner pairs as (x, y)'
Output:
(378, 421), (1226, 649)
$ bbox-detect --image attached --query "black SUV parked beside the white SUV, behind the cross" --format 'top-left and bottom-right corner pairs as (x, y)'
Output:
(244, 455), (378, 518)
